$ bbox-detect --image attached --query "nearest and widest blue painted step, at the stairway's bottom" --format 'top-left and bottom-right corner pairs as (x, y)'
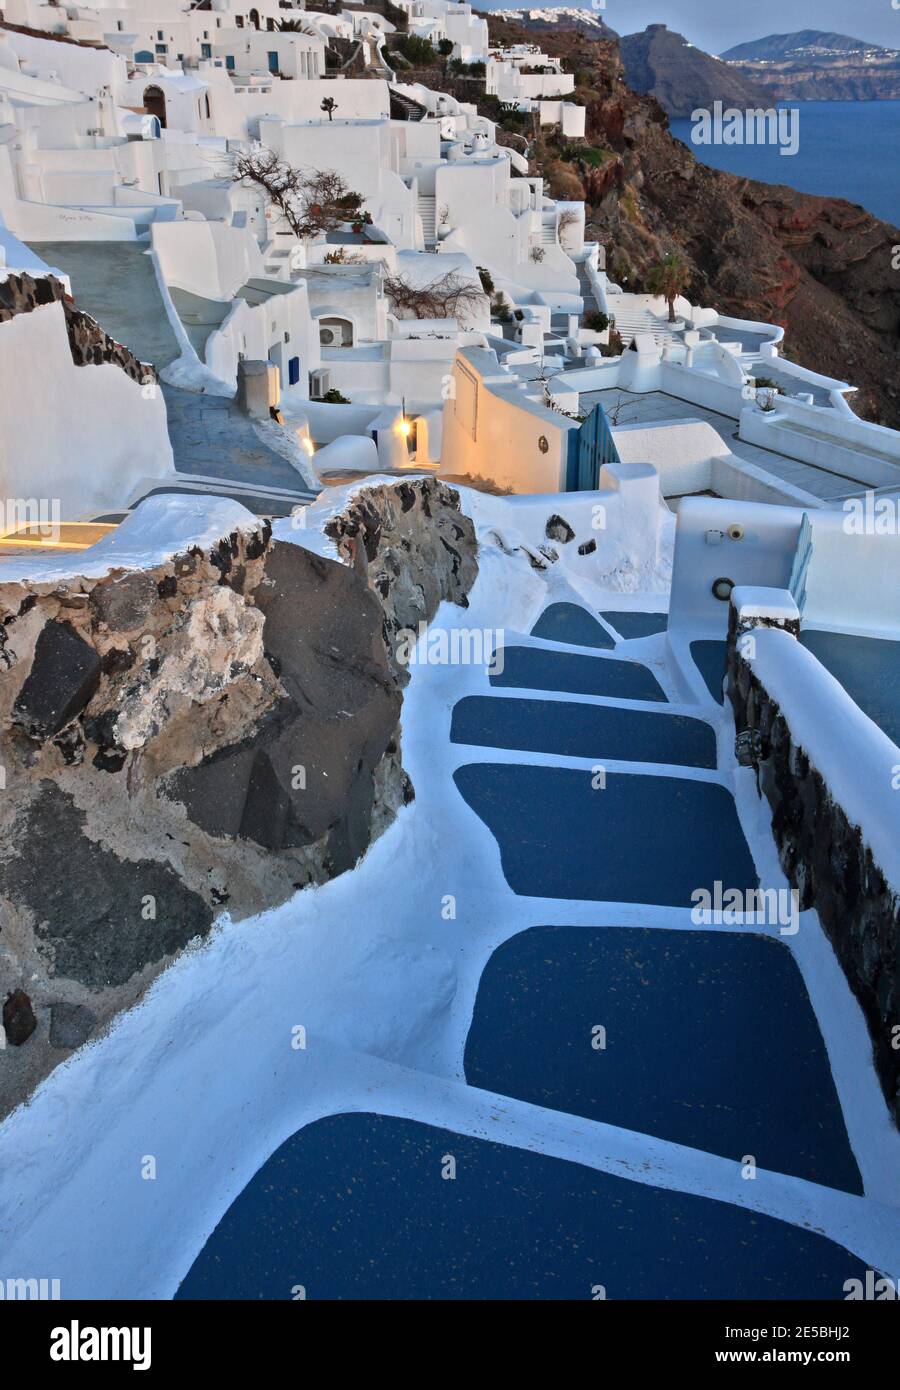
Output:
(172, 1113), (865, 1302)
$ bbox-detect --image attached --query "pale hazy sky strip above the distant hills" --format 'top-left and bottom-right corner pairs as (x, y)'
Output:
(473, 0), (900, 53)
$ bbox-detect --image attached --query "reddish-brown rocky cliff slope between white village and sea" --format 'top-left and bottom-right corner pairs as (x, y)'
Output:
(481, 14), (900, 428)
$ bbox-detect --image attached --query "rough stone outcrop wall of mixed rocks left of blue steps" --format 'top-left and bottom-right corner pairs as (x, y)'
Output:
(0, 480), (477, 1112)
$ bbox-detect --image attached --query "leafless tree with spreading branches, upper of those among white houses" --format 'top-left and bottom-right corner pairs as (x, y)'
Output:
(231, 146), (363, 240)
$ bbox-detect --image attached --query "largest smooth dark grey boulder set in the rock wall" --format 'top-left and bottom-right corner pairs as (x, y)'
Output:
(172, 542), (401, 863)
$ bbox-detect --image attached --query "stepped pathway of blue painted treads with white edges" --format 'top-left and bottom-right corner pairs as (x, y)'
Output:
(179, 592), (896, 1300)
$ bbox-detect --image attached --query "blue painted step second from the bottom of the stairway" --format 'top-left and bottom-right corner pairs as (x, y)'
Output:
(466, 927), (862, 1193)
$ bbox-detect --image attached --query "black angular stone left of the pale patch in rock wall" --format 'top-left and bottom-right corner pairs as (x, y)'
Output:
(13, 620), (102, 742)
